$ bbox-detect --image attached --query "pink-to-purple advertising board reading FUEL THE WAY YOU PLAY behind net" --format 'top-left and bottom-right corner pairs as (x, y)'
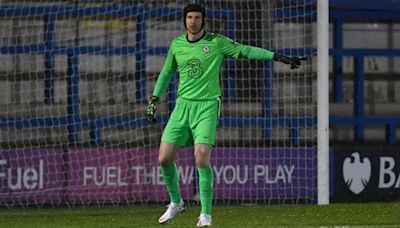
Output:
(0, 148), (317, 205)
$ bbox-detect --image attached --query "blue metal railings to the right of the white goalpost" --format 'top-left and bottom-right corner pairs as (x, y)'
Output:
(329, 7), (400, 144)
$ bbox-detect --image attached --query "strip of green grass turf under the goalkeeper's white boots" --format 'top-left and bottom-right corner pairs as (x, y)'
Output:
(0, 202), (400, 228)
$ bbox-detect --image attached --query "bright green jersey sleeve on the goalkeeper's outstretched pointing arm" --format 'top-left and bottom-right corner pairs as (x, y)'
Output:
(219, 36), (274, 60)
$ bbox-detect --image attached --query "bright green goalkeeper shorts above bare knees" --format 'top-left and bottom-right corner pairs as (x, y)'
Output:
(161, 98), (220, 147)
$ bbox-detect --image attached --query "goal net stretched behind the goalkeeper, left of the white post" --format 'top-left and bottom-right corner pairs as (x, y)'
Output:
(0, 0), (317, 207)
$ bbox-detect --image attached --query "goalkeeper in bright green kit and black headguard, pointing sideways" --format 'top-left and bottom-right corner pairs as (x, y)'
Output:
(146, 4), (304, 227)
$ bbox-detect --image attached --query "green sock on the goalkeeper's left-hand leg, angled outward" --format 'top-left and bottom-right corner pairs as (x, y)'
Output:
(161, 162), (181, 203)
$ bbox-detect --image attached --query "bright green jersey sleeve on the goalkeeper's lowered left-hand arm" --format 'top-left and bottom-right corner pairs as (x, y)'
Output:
(153, 43), (177, 97)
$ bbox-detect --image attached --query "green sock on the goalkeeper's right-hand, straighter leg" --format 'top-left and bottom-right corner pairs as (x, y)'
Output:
(197, 166), (214, 215)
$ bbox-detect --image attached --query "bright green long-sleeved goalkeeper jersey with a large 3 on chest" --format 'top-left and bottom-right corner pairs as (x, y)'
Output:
(153, 32), (274, 100)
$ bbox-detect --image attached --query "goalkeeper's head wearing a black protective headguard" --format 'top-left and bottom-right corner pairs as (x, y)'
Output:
(183, 3), (206, 34)
